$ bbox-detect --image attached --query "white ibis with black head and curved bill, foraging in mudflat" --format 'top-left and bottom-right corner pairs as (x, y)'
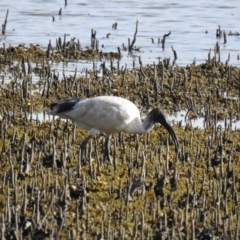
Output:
(48, 96), (179, 162)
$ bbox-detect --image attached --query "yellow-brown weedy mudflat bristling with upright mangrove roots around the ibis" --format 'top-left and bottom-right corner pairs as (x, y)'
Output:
(0, 34), (240, 239)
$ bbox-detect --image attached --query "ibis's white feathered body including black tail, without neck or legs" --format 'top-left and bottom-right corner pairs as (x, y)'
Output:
(49, 96), (141, 134)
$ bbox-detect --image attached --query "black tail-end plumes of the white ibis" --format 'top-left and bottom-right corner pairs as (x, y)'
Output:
(50, 98), (83, 113)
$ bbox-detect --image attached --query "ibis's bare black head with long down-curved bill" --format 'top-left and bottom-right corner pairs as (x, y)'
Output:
(148, 108), (179, 152)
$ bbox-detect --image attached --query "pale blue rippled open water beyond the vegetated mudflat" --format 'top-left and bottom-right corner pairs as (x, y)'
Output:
(0, 0), (240, 70)
